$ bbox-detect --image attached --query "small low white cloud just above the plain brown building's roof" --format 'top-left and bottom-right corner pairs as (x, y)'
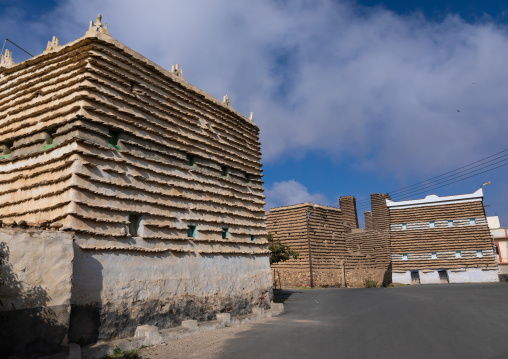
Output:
(265, 180), (328, 210)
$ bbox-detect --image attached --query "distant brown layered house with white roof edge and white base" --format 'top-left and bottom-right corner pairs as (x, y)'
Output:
(386, 188), (498, 284)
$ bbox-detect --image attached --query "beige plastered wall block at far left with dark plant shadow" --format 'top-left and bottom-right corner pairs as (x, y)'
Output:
(0, 227), (74, 356)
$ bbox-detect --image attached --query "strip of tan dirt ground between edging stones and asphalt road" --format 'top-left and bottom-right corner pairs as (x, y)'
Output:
(138, 317), (277, 359)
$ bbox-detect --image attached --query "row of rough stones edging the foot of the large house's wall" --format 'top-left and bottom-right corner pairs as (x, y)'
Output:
(79, 302), (284, 359)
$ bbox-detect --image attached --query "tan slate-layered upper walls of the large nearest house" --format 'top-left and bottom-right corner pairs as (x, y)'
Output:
(0, 30), (267, 255)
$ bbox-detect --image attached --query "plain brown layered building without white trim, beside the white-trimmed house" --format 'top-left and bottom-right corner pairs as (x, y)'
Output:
(266, 196), (390, 287)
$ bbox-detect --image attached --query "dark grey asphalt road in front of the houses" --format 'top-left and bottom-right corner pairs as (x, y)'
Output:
(220, 283), (508, 359)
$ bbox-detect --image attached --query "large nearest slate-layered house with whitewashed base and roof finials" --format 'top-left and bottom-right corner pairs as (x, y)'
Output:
(0, 17), (272, 353)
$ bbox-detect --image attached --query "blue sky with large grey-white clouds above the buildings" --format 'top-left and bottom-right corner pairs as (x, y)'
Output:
(0, 0), (508, 226)
